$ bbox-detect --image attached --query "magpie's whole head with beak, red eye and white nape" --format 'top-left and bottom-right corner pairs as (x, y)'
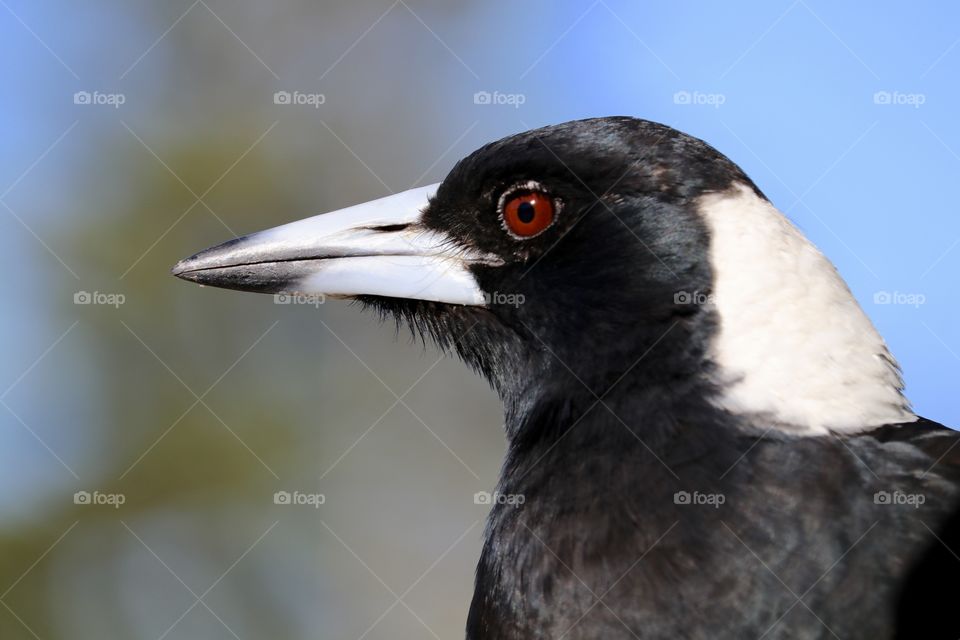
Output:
(173, 117), (916, 430)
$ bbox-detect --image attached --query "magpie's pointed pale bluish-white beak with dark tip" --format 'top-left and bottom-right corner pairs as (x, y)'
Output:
(173, 184), (496, 305)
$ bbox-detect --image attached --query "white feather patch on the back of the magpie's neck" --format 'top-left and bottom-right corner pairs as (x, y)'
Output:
(699, 184), (917, 435)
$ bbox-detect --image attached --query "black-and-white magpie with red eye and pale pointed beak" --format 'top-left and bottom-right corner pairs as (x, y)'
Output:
(173, 117), (960, 640)
